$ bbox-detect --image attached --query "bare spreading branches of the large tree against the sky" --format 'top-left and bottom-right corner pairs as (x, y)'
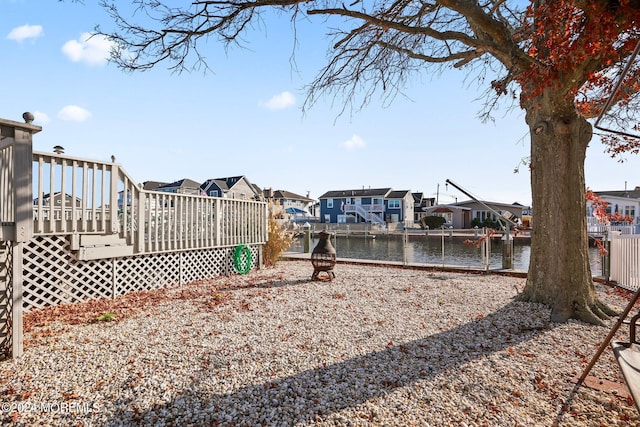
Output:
(96, 0), (637, 121)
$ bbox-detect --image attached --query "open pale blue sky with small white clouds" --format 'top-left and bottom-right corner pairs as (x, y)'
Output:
(0, 0), (640, 205)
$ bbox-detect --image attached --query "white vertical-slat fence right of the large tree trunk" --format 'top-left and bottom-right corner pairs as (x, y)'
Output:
(609, 234), (640, 291)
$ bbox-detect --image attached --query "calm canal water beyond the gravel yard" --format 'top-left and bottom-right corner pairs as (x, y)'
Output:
(289, 235), (602, 276)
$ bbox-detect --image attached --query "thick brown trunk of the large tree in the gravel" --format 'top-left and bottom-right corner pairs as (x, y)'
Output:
(521, 93), (613, 324)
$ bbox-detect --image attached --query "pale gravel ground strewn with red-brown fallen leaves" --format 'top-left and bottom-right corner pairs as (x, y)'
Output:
(0, 261), (640, 426)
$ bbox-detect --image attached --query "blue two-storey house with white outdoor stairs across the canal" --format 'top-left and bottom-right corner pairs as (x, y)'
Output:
(319, 188), (414, 226)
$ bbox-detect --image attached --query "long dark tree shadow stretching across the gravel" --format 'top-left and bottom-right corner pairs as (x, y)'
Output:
(100, 301), (553, 426)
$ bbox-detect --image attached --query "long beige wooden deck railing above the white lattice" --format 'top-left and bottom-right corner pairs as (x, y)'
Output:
(33, 152), (267, 254)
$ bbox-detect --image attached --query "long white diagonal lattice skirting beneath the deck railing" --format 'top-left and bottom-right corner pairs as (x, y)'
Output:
(21, 235), (260, 312)
